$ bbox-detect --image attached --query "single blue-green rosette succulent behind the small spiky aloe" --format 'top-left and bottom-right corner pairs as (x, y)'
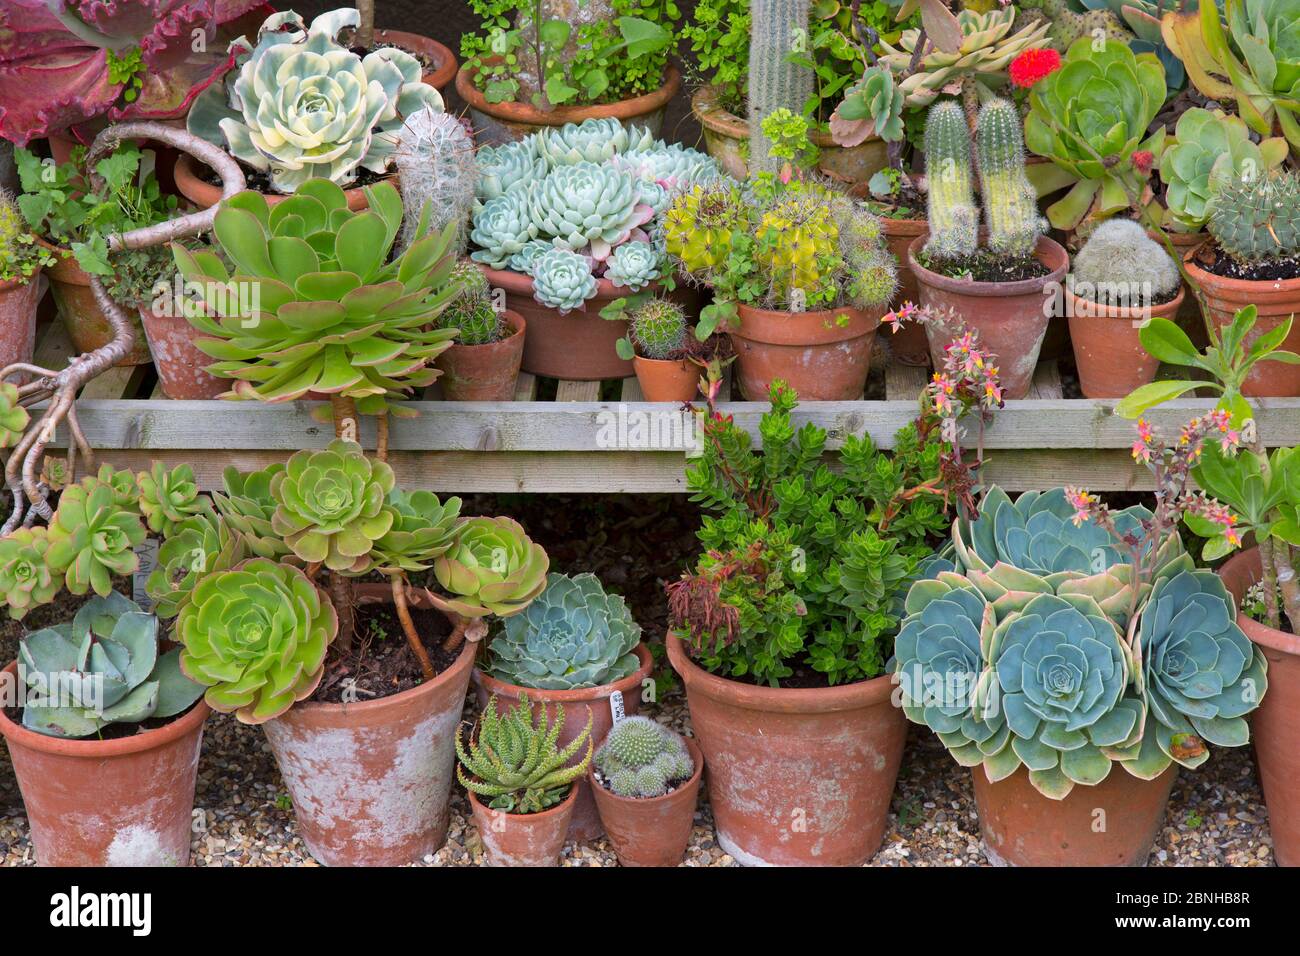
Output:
(488, 574), (641, 691)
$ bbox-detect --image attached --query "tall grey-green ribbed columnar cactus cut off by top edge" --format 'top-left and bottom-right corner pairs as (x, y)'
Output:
(749, 0), (813, 174)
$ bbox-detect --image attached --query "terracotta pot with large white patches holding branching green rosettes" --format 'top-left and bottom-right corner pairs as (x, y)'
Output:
(263, 608), (476, 866)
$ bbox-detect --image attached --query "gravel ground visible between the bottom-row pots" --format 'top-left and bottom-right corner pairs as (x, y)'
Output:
(0, 695), (1273, 866)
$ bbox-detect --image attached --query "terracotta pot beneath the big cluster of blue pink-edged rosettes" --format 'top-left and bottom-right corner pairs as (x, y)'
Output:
(971, 763), (1178, 866)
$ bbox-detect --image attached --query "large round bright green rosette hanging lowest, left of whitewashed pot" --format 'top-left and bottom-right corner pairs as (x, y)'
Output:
(174, 558), (338, 723)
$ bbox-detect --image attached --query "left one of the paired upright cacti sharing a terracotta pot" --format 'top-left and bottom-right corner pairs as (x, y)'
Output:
(926, 100), (979, 259)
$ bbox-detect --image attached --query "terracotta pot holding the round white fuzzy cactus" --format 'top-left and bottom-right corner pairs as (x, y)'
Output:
(1065, 289), (1184, 398)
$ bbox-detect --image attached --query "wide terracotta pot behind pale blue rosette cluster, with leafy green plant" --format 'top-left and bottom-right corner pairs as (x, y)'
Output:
(456, 64), (681, 146)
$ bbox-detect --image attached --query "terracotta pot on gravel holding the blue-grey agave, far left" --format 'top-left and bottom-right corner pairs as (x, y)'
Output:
(0, 663), (211, 866)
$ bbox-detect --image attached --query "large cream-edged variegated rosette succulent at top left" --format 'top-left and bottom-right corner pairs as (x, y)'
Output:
(187, 8), (442, 194)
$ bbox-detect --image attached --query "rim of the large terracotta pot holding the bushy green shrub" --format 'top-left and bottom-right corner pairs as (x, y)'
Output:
(664, 632), (893, 714)
